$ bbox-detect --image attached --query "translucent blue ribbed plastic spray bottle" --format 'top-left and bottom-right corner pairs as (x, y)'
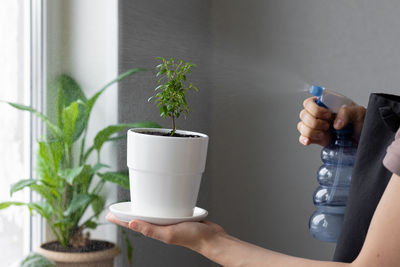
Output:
(309, 85), (357, 243)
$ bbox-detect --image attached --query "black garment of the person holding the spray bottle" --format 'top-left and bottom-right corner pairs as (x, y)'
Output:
(333, 94), (400, 262)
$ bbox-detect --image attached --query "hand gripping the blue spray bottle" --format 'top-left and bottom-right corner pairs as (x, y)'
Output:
(297, 97), (366, 146)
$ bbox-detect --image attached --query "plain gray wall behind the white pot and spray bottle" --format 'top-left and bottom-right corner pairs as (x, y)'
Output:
(119, 0), (400, 266)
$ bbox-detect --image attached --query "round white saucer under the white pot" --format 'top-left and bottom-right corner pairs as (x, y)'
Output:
(109, 202), (208, 225)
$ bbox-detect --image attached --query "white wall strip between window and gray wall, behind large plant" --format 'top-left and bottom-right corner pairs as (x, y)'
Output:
(47, 0), (118, 242)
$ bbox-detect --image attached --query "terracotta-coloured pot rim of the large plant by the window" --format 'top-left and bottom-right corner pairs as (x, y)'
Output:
(36, 242), (121, 267)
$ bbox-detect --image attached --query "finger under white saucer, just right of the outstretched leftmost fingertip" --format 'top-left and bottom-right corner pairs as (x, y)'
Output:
(129, 220), (173, 244)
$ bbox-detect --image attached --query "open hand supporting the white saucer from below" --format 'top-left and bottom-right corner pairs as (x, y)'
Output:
(106, 212), (226, 254)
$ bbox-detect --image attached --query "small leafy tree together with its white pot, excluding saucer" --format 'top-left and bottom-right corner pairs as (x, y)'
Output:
(127, 58), (208, 218)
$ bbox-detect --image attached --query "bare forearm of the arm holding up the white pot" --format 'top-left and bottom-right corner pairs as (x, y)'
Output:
(198, 234), (351, 267)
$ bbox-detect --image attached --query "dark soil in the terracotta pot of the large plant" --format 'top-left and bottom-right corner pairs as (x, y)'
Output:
(42, 240), (114, 253)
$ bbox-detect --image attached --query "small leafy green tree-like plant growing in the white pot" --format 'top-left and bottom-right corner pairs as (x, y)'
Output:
(149, 57), (198, 136)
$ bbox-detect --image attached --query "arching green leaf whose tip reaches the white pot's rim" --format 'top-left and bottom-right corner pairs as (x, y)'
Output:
(94, 121), (161, 151)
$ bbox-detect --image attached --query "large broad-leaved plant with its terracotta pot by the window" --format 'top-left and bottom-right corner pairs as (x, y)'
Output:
(0, 68), (160, 266)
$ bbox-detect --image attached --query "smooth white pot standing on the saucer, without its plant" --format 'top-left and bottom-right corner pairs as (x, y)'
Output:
(127, 128), (208, 218)
